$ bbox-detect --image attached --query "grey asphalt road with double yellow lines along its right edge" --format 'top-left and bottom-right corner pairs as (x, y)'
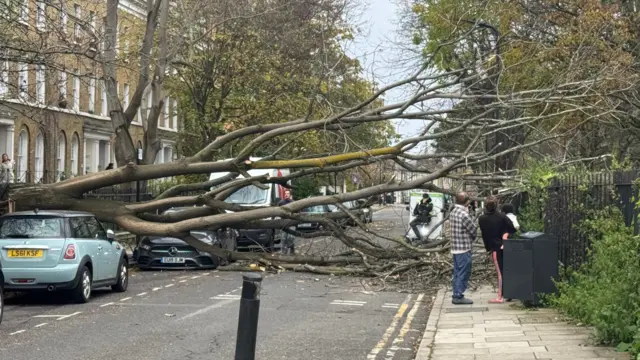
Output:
(0, 205), (432, 360)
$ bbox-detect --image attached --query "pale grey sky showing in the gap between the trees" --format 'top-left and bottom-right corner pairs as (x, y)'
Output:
(346, 0), (424, 142)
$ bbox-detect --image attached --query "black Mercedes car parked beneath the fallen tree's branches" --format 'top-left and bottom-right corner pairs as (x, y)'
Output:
(133, 230), (233, 269)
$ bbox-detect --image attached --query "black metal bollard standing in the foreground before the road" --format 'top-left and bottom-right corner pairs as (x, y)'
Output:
(235, 273), (262, 360)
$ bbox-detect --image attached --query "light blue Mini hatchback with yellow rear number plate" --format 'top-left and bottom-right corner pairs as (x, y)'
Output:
(0, 210), (129, 303)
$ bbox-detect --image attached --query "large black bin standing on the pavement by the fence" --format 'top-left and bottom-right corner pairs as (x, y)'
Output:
(502, 231), (558, 305)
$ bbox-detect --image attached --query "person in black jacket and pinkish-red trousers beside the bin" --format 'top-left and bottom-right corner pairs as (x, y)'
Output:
(478, 197), (516, 303)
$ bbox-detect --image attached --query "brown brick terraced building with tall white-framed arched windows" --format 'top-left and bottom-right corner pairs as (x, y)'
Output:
(0, 0), (179, 183)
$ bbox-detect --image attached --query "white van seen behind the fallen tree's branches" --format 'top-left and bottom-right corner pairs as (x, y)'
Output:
(209, 158), (290, 251)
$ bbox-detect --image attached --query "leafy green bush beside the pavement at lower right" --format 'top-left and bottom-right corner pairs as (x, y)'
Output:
(550, 207), (640, 359)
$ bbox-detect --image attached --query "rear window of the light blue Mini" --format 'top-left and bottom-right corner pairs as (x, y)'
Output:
(0, 216), (64, 239)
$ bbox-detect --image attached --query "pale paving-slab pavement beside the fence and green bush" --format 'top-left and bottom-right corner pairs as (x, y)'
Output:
(415, 287), (630, 360)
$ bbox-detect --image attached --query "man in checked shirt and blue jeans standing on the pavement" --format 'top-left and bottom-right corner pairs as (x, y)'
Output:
(449, 192), (478, 305)
